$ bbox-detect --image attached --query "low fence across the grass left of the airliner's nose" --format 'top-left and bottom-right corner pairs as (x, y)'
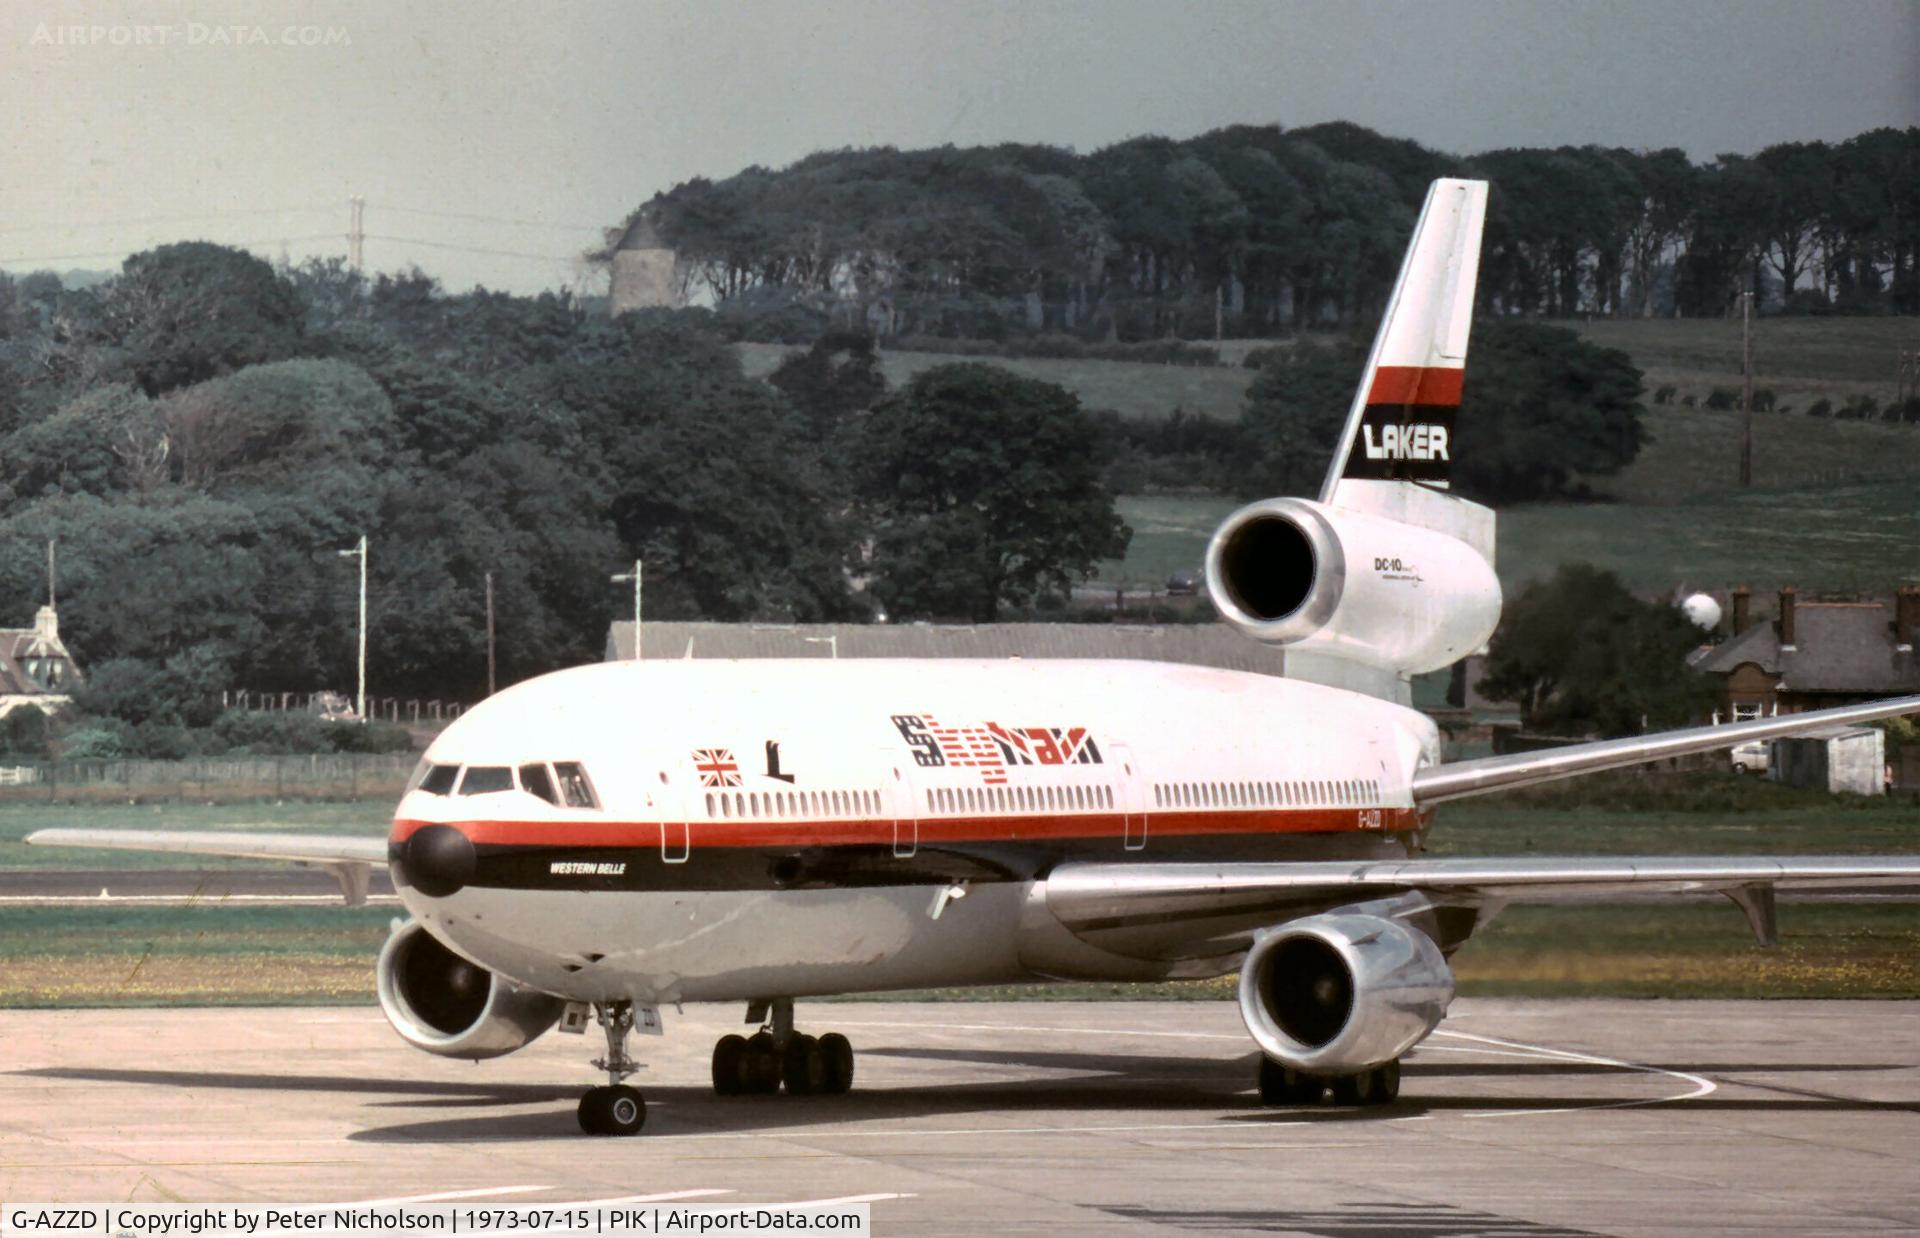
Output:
(0, 752), (419, 804)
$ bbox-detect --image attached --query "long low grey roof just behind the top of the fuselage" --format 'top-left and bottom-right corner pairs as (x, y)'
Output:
(607, 622), (1284, 676)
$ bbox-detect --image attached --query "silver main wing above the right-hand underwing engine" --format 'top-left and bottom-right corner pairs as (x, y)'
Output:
(1044, 854), (1920, 956)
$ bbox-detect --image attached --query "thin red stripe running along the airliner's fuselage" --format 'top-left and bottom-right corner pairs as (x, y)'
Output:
(392, 808), (1419, 846)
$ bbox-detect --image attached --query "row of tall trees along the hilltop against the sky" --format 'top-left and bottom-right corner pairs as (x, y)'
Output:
(599, 123), (1920, 340)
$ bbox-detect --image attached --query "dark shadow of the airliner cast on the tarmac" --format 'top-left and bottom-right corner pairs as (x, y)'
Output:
(17, 1048), (1920, 1142)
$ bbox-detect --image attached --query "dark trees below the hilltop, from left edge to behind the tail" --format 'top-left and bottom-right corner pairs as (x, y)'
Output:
(0, 232), (1640, 754)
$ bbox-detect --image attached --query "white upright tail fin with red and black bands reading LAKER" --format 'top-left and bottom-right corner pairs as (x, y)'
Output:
(1321, 180), (1486, 506)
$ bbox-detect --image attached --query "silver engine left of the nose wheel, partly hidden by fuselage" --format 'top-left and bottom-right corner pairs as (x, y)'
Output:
(374, 919), (566, 1061)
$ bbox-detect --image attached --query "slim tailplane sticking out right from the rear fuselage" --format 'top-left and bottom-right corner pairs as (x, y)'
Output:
(1413, 697), (1920, 808)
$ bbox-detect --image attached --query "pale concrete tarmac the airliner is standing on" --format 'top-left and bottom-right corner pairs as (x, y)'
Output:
(0, 998), (1920, 1236)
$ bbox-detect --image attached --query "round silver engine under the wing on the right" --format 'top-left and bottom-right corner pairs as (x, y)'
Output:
(1240, 912), (1453, 1075)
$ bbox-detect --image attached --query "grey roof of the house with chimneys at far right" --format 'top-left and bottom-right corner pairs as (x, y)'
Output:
(1693, 603), (1920, 695)
